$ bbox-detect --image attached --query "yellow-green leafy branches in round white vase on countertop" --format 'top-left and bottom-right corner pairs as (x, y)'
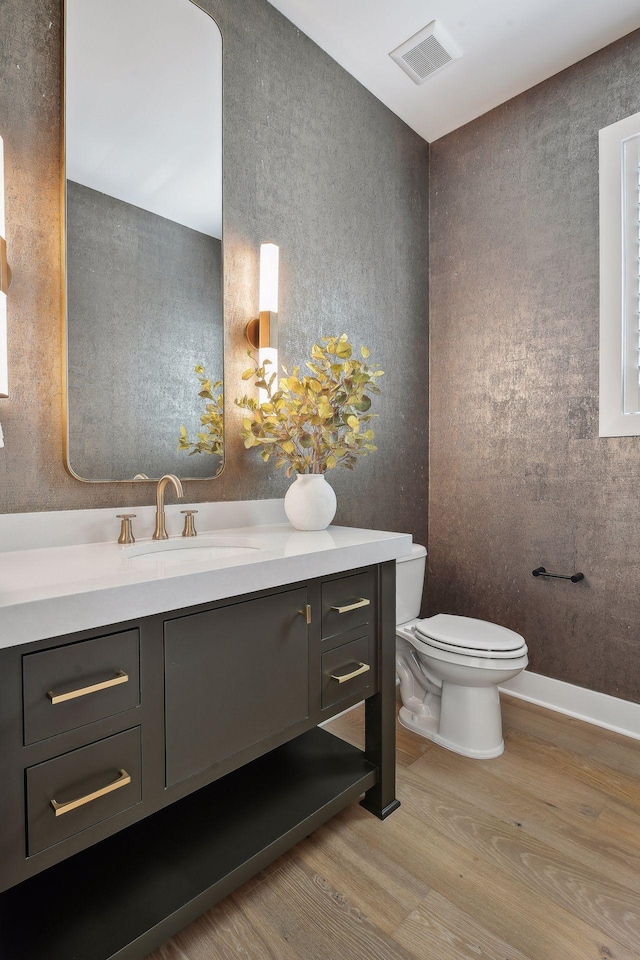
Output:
(236, 333), (383, 530)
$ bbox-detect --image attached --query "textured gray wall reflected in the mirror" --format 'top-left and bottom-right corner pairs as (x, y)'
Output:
(67, 181), (224, 480)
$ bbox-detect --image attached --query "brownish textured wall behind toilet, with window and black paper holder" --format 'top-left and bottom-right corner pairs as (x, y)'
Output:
(429, 32), (640, 701)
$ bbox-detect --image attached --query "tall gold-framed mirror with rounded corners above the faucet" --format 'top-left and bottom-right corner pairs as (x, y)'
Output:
(64, 0), (223, 481)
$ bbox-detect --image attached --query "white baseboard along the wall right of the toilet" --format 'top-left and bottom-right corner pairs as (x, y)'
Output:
(500, 670), (640, 740)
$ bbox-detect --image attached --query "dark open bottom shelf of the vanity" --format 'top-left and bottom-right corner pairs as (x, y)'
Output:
(0, 728), (377, 960)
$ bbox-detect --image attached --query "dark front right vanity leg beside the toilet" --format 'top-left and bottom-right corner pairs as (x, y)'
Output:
(360, 560), (400, 820)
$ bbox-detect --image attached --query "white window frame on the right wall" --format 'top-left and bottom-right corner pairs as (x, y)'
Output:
(600, 113), (640, 437)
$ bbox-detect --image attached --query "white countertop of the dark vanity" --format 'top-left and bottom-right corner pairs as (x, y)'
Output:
(0, 523), (412, 647)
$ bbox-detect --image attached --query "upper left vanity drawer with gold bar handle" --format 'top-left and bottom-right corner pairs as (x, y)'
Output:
(22, 629), (140, 744)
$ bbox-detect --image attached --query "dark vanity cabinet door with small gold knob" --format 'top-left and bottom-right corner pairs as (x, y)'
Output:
(164, 588), (309, 786)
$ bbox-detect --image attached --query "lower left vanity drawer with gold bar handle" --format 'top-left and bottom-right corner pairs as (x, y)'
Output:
(26, 727), (142, 856)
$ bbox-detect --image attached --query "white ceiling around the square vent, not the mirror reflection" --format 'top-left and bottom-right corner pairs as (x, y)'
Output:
(270, 0), (640, 142)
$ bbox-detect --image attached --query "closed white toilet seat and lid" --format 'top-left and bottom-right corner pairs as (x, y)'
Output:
(415, 613), (527, 657)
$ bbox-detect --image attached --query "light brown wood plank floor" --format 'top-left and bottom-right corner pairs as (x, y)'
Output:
(148, 698), (640, 960)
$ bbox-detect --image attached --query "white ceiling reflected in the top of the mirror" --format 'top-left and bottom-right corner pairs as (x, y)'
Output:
(65, 0), (222, 238)
